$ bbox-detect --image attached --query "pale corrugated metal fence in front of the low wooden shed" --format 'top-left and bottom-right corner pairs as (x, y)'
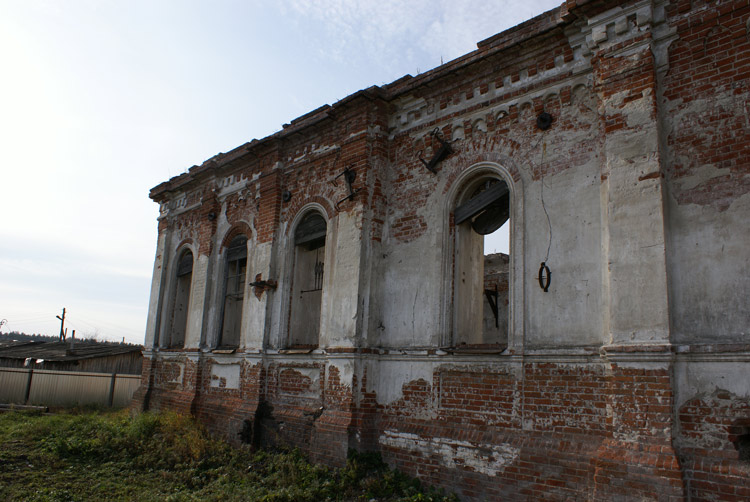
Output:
(0, 368), (141, 407)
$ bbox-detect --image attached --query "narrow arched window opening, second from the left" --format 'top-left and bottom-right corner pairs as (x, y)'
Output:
(219, 235), (247, 347)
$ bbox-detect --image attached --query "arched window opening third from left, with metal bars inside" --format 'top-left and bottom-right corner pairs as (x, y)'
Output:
(289, 212), (327, 349)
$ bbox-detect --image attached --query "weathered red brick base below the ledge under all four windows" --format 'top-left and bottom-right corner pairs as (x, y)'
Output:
(138, 359), (692, 500)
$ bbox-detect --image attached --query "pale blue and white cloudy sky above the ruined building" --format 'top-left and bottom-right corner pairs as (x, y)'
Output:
(0, 0), (562, 343)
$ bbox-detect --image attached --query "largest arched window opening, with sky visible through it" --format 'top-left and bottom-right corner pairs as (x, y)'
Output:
(453, 177), (510, 351)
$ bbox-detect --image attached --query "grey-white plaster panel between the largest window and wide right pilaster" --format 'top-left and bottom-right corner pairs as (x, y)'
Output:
(526, 165), (604, 347)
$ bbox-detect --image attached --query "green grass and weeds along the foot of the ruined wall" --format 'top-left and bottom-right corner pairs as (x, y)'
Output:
(0, 411), (456, 502)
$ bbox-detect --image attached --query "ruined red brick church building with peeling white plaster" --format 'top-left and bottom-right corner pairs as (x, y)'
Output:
(134, 0), (750, 501)
